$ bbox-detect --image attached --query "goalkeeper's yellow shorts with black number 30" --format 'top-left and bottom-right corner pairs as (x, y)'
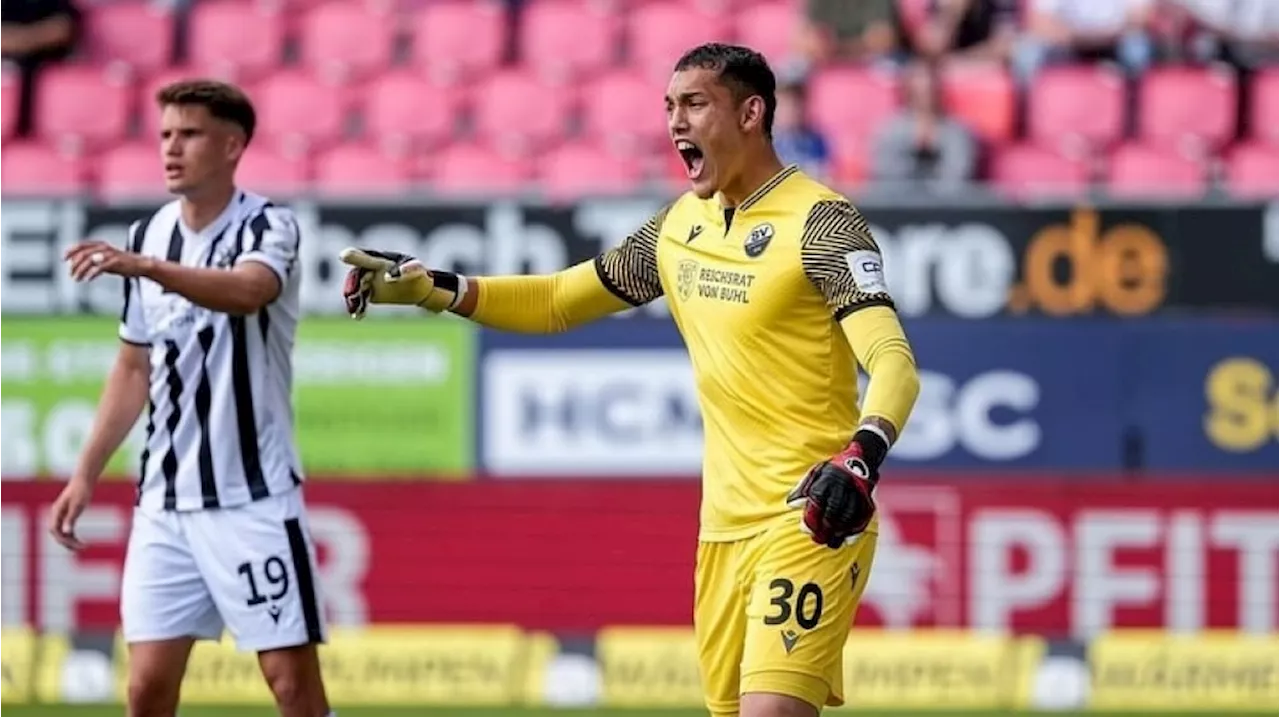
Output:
(694, 513), (877, 716)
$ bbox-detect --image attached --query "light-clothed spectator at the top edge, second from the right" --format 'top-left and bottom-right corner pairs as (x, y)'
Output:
(1014, 0), (1157, 85)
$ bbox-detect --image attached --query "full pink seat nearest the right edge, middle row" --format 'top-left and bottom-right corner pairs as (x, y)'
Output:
(1138, 67), (1235, 150)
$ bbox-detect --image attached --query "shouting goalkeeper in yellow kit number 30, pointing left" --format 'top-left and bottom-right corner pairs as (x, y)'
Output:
(342, 44), (919, 717)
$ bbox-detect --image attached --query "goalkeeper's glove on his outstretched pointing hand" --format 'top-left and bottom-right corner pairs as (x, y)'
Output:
(339, 247), (467, 319)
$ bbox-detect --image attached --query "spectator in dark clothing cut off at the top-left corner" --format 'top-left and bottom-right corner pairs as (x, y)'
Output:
(0, 0), (82, 137)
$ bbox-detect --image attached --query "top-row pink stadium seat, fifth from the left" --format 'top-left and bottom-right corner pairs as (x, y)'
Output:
(517, 0), (621, 82)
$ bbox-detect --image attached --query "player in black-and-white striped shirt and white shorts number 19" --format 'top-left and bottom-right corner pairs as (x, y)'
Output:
(50, 81), (332, 717)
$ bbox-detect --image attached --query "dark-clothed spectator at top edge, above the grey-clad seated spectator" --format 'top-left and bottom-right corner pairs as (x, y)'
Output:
(911, 0), (1018, 63)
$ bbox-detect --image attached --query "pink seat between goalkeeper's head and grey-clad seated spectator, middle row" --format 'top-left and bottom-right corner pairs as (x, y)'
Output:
(808, 67), (899, 140)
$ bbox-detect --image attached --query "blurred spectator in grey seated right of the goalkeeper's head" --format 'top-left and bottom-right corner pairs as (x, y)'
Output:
(872, 60), (978, 192)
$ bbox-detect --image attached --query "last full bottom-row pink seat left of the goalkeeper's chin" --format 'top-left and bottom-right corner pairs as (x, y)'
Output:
(538, 142), (645, 200)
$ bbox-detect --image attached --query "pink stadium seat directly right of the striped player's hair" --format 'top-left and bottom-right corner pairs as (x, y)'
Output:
(253, 70), (347, 146)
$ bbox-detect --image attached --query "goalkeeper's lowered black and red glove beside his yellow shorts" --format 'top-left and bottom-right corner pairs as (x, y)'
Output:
(787, 428), (888, 548)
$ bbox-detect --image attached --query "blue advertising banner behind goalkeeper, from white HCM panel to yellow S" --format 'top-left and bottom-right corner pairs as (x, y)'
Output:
(477, 319), (1280, 478)
